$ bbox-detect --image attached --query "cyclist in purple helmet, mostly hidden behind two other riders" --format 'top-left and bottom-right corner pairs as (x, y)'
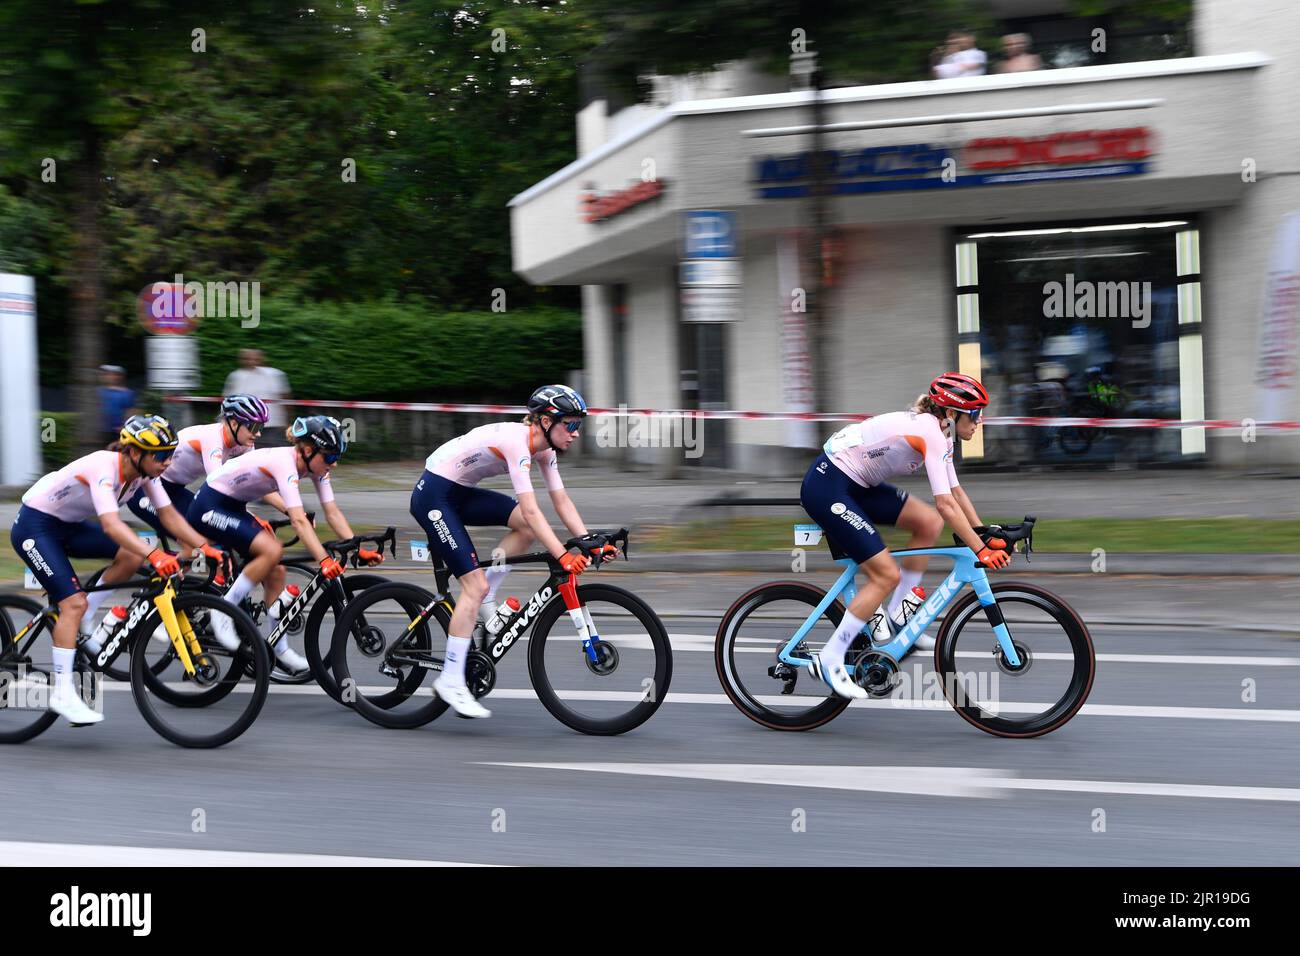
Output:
(127, 395), (269, 535)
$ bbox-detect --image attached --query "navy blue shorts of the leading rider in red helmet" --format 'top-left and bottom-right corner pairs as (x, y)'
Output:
(800, 454), (907, 564)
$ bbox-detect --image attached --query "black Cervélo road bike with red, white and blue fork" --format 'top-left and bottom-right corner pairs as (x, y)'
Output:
(330, 528), (672, 735)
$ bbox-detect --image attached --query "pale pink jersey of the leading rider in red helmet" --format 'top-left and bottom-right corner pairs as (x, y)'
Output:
(822, 411), (958, 494)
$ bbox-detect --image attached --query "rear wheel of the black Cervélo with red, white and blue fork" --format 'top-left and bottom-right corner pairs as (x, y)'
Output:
(330, 581), (451, 730)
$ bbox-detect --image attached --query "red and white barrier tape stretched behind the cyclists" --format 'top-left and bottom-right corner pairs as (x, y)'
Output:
(173, 395), (1300, 431)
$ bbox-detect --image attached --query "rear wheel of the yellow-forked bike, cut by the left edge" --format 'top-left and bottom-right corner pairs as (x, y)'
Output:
(0, 594), (59, 744)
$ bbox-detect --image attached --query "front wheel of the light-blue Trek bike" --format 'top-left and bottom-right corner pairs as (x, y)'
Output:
(935, 581), (1097, 737)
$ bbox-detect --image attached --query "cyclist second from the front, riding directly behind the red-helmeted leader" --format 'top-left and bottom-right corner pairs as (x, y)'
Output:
(411, 385), (616, 717)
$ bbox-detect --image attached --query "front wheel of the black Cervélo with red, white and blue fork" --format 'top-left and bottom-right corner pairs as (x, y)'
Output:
(525, 584), (672, 736)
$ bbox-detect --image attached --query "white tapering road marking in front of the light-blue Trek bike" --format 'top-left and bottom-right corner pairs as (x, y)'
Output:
(484, 761), (1300, 803)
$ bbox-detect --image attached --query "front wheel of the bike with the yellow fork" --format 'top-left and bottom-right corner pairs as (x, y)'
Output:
(130, 592), (270, 748)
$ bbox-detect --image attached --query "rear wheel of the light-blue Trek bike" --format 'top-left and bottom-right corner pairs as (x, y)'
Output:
(714, 581), (849, 730)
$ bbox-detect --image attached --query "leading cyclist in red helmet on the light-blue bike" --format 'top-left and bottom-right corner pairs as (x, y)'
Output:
(800, 372), (1010, 698)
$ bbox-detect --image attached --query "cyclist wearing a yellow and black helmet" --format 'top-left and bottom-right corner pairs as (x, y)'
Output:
(9, 415), (220, 726)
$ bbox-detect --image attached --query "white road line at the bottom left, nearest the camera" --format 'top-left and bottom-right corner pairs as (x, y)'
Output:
(0, 842), (490, 866)
